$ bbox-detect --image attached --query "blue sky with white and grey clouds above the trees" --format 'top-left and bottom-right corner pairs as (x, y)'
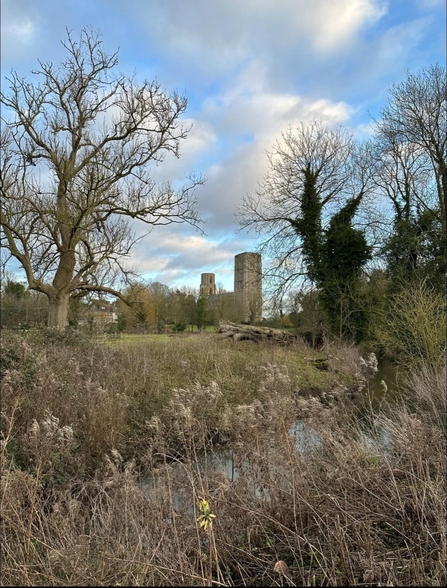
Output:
(1, 0), (446, 291)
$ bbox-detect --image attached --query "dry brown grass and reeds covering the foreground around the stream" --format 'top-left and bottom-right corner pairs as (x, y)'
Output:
(2, 333), (445, 586)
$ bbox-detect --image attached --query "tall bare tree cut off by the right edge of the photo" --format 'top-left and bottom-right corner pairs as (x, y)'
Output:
(376, 65), (447, 288)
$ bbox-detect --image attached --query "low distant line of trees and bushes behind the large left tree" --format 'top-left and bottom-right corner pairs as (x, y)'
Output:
(0, 275), (240, 333)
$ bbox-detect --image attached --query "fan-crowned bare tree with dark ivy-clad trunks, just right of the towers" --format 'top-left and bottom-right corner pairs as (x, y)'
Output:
(239, 123), (373, 335)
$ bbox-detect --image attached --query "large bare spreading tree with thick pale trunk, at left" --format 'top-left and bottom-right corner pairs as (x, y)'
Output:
(1, 30), (203, 326)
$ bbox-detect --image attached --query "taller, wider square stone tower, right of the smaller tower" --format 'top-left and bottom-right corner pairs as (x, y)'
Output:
(234, 252), (262, 324)
